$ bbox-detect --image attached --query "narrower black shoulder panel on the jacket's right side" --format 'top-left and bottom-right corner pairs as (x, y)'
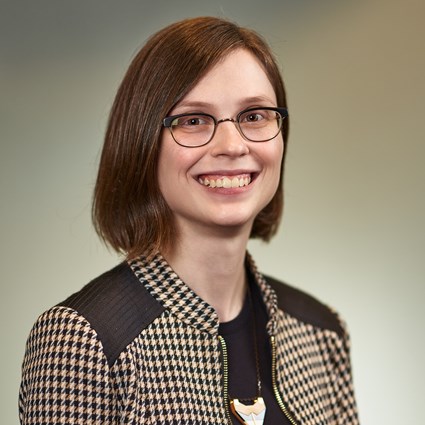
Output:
(264, 276), (345, 337)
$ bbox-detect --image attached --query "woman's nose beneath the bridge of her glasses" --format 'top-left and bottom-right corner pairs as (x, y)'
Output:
(211, 118), (249, 157)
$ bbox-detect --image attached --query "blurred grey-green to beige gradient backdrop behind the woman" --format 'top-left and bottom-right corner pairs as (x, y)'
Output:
(0, 0), (425, 425)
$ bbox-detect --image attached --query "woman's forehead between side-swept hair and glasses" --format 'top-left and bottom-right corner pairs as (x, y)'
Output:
(177, 49), (276, 111)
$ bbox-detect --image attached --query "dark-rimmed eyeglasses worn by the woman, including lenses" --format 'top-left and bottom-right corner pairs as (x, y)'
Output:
(163, 107), (288, 148)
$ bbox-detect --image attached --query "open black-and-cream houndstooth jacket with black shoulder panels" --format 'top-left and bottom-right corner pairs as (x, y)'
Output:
(19, 255), (358, 425)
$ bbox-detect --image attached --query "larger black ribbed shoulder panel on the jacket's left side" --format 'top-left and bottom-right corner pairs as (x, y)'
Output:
(58, 263), (164, 366)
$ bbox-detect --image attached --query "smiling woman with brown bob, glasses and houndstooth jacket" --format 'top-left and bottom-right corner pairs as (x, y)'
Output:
(20, 18), (358, 425)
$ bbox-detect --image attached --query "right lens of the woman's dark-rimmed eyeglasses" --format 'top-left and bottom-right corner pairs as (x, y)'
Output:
(238, 109), (283, 142)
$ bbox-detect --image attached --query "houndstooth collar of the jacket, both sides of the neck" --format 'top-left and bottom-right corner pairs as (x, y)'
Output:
(128, 253), (277, 335)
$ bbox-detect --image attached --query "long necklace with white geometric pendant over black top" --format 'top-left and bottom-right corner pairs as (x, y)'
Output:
(230, 285), (266, 425)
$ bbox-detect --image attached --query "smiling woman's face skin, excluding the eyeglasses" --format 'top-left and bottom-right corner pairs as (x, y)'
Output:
(158, 49), (284, 237)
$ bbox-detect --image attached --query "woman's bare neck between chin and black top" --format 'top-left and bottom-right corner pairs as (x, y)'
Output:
(163, 224), (250, 322)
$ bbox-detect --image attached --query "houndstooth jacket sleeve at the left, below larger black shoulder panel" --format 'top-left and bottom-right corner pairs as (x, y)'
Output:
(19, 307), (116, 425)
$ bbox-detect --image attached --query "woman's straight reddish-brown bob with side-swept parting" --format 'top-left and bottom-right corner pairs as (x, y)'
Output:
(92, 17), (288, 259)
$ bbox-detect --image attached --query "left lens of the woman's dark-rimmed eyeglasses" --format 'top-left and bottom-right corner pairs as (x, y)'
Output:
(170, 114), (215, 147)
